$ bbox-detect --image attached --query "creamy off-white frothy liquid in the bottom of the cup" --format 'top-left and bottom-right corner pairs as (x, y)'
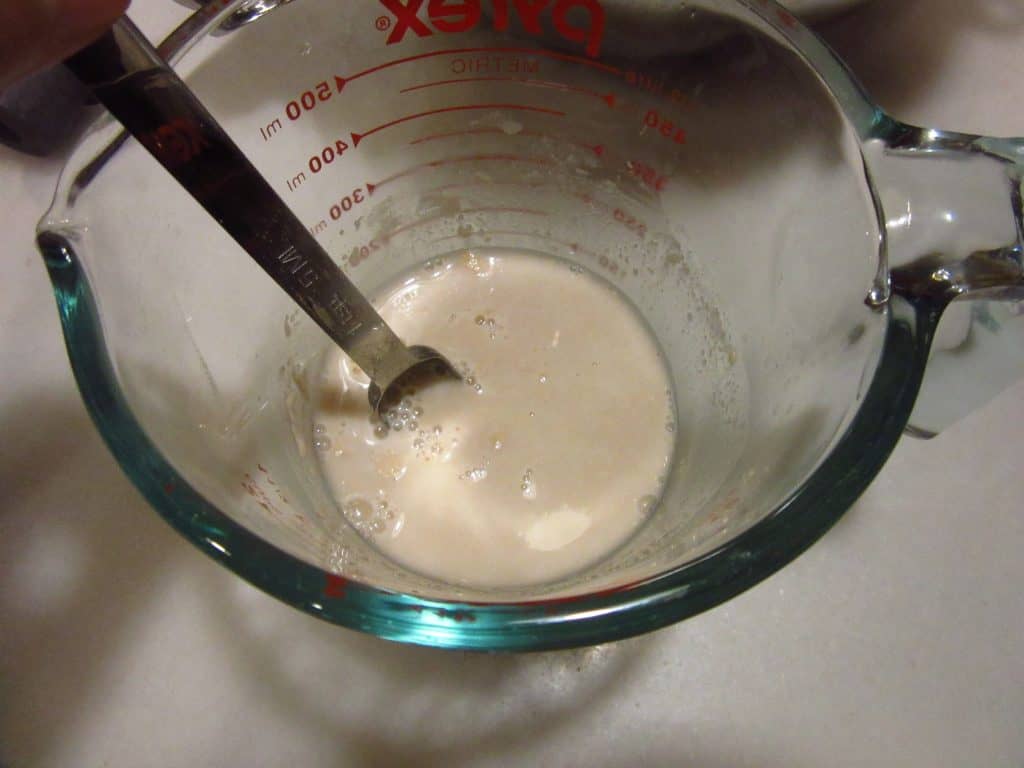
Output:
(313, 251), (675, 587)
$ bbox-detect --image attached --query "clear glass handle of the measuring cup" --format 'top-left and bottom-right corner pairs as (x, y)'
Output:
(865, 118), (1024, 437)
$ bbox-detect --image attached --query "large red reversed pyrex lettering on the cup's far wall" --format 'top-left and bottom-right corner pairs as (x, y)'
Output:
(380, 0), (604, 58)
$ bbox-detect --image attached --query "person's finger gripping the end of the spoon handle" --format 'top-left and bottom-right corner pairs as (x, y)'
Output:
(0, 0), (129, 88)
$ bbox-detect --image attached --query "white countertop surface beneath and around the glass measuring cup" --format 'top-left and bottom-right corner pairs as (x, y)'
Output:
(0, 0), (1024, 768)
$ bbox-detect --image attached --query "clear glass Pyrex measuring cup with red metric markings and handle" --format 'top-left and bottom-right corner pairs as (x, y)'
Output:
(40, 0), (1021, 648)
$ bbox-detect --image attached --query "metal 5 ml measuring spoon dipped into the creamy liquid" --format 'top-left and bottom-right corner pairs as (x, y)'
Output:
(66, 16), (458, 413)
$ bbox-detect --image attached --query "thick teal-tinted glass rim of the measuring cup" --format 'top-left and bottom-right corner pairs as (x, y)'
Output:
(37, 0), (939, 650)
